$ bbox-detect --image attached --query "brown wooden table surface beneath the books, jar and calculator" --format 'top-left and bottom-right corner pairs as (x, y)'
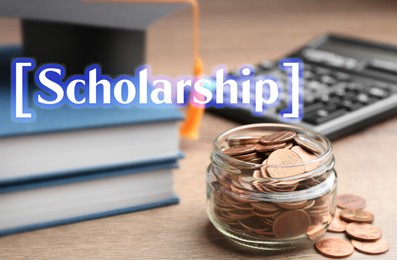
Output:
(0, 0), (397, 259)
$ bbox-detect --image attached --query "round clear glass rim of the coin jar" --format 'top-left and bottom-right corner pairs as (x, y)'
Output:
(212, 123), (332, 181)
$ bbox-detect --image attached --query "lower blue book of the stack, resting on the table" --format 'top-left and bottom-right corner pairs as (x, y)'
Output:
(0, 161), (179, 236)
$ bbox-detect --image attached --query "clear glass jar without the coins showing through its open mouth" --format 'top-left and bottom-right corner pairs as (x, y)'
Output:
(206, 124), (337, 250)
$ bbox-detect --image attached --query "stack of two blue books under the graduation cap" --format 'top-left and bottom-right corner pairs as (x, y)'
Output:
(0, 48), (182, 235)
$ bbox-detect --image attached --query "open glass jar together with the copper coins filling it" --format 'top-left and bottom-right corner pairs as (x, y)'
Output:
(207, 124), (337, 250)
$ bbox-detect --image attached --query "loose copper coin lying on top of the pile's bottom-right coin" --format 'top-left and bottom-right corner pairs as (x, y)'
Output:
(346, 223), (382, 241)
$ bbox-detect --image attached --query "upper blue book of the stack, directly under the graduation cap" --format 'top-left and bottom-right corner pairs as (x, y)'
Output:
(0, 47), (183, 185)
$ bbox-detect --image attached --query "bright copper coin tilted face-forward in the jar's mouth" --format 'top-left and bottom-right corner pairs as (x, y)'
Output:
(266, 149), (305, 178)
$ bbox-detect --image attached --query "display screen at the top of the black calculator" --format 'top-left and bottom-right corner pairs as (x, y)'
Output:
(317, 39), (397, 63)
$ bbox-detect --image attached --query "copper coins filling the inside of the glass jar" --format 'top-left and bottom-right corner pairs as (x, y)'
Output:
(212, 131), (333, 239)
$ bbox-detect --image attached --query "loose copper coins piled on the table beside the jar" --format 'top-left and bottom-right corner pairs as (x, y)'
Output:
(316, 194), (389, 258)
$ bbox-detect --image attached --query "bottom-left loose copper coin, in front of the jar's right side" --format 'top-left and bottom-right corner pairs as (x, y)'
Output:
(316, 237), (354, 258)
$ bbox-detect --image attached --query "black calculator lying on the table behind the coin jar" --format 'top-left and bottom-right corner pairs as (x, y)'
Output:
(209, 34), (397, 139)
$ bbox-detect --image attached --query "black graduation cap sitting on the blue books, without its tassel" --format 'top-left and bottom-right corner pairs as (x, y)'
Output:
(0, 0), (183, 75)
